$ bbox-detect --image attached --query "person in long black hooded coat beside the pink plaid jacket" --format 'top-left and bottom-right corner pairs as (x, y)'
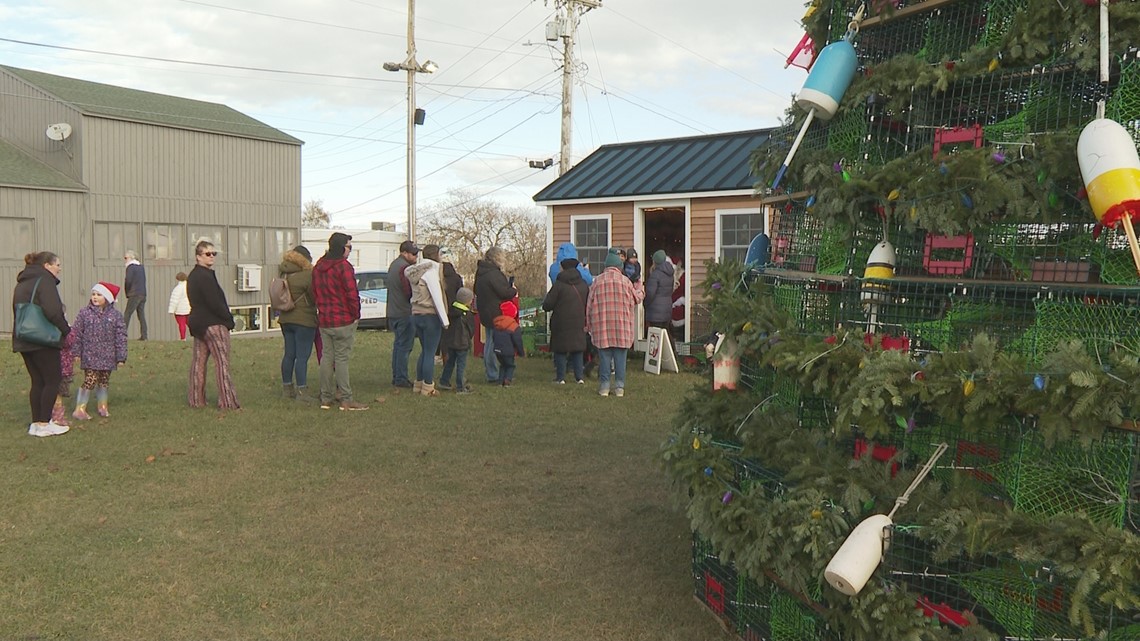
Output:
(543, 258), (589, 386)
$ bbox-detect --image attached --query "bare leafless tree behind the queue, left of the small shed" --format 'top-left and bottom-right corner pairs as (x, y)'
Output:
(421, 189), (546, 297)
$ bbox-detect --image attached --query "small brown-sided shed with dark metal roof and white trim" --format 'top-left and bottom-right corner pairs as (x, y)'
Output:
(535, 129), (774, 341)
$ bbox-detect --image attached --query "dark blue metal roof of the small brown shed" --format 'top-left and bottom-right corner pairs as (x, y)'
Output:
(535, 128), (775, 202)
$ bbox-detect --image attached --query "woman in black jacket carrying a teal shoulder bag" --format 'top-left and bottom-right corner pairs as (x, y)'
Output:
(11, 252), (71, 437)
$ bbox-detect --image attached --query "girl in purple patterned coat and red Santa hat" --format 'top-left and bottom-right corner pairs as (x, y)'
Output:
(72, 282), (127, 421)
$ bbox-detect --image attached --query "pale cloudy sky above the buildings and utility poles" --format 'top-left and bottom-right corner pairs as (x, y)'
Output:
(0, 0), (806, 228)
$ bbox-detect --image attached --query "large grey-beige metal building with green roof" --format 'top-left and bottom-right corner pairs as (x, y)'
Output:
(0, 66), (302, 340)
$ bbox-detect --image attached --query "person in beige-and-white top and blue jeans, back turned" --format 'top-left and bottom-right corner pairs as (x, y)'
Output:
(404, 245), (449, 396)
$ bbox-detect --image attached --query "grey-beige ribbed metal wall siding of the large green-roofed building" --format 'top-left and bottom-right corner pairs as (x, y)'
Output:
(0, 114), (301, 340)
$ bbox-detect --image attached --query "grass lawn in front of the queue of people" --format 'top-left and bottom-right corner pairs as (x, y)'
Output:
(0, 332), (724, 641)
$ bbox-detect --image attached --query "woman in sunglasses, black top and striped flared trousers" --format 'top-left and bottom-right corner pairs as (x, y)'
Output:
(186, 241), (241, 409)
